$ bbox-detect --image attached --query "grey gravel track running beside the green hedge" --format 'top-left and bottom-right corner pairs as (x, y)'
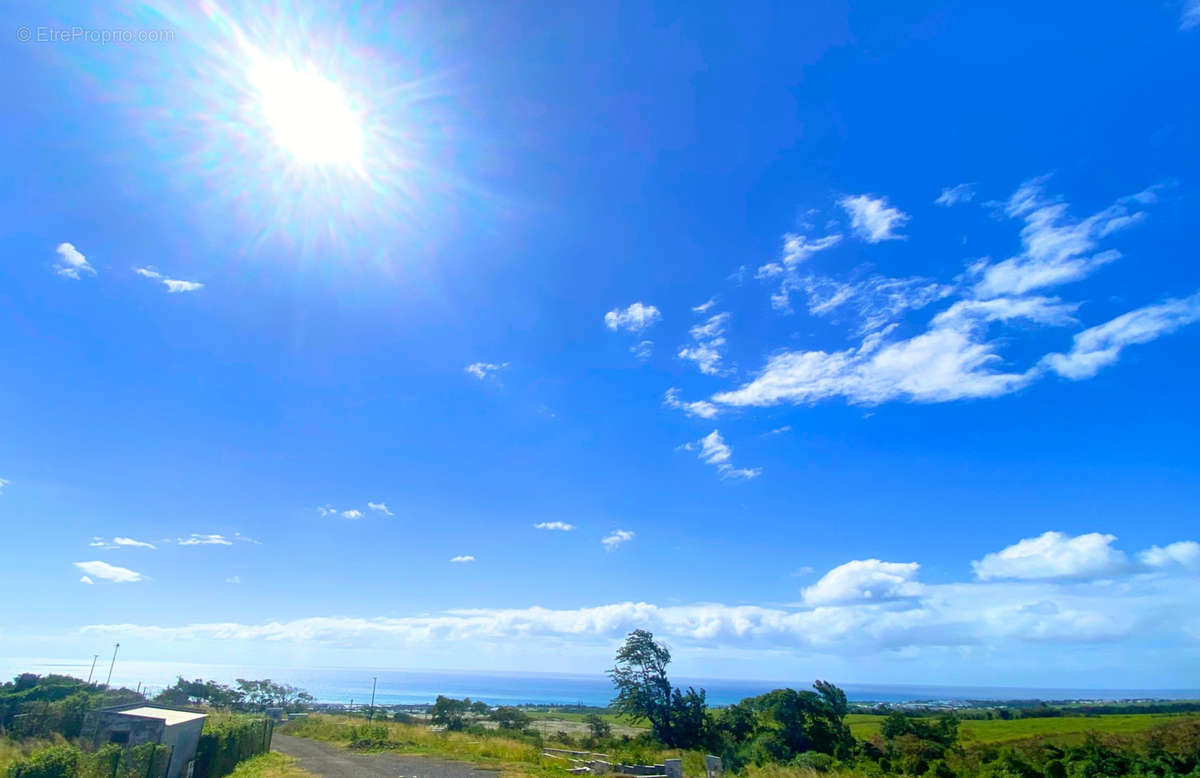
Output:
(271, 735), (499, 778)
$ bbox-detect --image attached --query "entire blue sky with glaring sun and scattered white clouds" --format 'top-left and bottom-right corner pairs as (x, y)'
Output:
(0, 1), (1200, 688)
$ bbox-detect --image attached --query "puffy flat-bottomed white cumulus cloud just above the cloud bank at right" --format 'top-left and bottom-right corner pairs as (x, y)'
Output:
(971, 532), (1128, 581)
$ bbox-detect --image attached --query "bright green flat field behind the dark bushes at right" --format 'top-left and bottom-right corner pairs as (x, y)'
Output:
(846, 713), (1200, 746)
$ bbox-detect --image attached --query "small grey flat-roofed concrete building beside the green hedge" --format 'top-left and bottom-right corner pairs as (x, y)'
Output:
(82, 702), (205, 778)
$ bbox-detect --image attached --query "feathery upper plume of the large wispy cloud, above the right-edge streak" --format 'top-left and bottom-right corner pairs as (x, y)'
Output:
(967, 176), (1146, 298)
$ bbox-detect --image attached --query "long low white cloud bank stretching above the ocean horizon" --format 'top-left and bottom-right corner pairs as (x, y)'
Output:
(80, 533), (1200, 657)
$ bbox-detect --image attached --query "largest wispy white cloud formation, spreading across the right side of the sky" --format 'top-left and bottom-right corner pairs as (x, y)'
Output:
(700, 179), (1200, 415)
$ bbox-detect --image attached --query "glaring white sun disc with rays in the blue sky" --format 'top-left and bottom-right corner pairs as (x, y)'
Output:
(250, 58), (362, 168)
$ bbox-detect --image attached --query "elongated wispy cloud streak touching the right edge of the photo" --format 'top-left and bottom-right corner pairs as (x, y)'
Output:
(1042, 292), (1200, 381)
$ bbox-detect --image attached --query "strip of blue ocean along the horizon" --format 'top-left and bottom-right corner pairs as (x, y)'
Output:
(11, 660), (1200, 706)
